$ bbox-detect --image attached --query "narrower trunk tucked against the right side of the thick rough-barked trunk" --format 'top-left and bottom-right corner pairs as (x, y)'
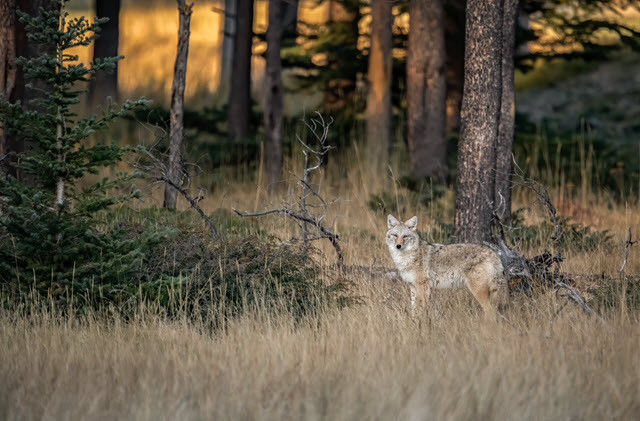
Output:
(495, 0), (518, 223)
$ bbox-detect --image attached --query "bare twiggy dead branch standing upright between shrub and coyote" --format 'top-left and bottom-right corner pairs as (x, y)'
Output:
(233, 112), (344, 266)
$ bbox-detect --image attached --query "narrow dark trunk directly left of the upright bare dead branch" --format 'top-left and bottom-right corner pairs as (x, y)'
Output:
(264, 0), (284, 190)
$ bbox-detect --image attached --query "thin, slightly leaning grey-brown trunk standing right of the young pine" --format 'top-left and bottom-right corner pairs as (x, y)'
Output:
(163, 0), (193, 209)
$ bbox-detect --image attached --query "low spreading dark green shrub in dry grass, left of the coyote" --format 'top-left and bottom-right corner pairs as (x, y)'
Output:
(128, 230), (348, 316)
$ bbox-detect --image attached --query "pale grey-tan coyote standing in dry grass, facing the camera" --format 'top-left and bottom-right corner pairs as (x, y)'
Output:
(387, 215), (508, 315)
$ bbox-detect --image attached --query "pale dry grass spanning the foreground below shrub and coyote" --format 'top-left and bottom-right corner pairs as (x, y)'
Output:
(0, 282), (640, 420)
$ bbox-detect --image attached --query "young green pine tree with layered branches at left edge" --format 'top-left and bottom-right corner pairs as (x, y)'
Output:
(0, 0), (146, 297)
